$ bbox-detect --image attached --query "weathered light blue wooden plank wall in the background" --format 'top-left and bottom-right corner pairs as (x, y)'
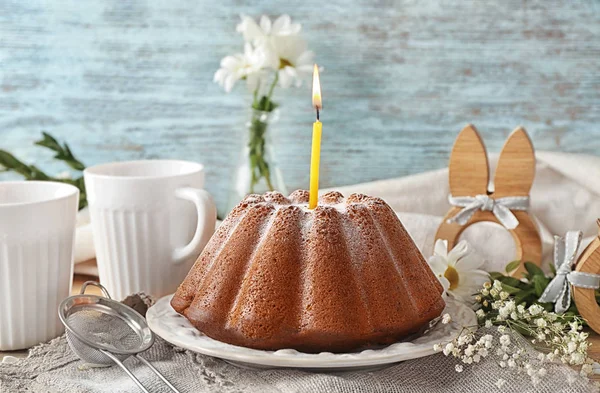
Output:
(0, 0), (600, 211)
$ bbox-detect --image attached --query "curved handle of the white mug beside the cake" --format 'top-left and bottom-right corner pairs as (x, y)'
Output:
(173, 187), (217, 264)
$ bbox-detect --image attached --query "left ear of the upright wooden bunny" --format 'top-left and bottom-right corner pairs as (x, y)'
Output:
(449, 124), (490, 197)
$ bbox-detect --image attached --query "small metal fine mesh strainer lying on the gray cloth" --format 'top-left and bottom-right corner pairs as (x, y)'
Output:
(58, 281), (179, 393)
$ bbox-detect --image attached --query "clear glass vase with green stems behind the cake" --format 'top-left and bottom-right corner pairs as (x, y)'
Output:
(228, 109), (287, 210)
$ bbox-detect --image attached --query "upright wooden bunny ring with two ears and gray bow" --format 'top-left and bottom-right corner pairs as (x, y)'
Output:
(435, 124), (542, 277)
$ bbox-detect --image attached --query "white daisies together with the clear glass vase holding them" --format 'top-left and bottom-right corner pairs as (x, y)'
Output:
(214, 15), (314, 204)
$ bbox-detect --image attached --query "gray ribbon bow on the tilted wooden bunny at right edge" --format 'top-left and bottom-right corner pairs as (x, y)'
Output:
(539, 231), (600, 314)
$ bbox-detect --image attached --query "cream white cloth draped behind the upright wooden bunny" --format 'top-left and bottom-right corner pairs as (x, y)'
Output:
(334, 152), (600, 271)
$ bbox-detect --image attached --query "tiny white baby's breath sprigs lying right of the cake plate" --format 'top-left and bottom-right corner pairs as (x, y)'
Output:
(434, 281), (594, 386)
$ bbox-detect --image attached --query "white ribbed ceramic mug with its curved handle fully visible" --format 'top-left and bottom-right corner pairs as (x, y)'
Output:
(84, 160), (217, 299)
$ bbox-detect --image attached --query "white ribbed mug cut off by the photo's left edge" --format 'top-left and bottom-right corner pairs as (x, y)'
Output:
(0, 181), (79, 351)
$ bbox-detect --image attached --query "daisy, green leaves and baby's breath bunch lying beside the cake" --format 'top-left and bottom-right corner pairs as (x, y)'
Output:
(429, 240), (594, 388)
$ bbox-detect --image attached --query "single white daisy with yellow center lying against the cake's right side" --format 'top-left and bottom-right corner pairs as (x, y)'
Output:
(428, 239), (489, 303)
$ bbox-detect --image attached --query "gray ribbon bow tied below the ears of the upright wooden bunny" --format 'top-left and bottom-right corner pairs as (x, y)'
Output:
(447, 195), (529, 229)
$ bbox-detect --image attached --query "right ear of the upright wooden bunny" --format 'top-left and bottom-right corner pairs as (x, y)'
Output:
(494, 127), (535, 198)
